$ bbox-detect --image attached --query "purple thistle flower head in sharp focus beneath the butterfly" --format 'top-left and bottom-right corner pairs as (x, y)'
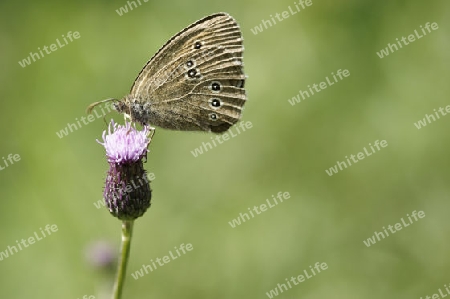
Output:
(97, 121), (152, 220)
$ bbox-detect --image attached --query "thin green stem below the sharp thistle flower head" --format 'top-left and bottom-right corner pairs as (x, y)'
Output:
(113, 220), (134, 299)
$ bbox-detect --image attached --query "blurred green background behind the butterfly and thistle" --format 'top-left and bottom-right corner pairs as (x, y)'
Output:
(0, 0), (450, 299)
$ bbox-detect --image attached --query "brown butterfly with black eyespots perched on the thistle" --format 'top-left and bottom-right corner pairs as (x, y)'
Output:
(88, 13), (247, 133)
